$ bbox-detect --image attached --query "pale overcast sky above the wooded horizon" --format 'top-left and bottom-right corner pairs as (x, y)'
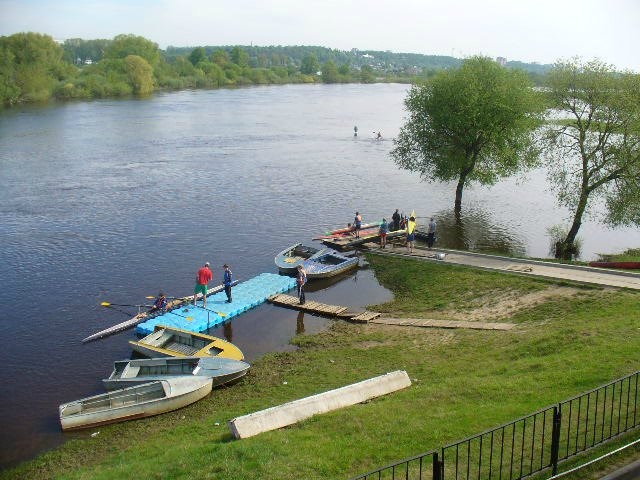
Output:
(0, 0), (640, 72)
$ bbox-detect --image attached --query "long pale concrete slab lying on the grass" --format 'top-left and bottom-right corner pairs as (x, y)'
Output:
(228, 370), (411, 439)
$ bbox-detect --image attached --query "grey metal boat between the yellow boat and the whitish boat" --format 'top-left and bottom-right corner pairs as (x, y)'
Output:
(102, 357), (251, 390)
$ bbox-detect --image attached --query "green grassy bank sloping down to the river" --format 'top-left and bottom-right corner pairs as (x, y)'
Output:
(1, 256), (640, 479)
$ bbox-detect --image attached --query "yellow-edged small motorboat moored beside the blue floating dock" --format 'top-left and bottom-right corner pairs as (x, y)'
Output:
(129, 325), (244, 360)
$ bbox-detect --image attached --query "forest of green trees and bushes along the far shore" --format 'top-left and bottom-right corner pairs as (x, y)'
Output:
(0, 32), (551, 106)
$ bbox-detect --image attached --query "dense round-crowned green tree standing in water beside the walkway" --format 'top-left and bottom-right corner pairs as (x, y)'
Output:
(391, 57), (543, 213)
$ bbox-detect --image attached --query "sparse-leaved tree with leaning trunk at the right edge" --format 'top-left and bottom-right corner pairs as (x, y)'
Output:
(545, 59), (640, 258)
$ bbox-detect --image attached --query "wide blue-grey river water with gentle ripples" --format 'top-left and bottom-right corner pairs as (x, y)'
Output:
(0, 84), (640, 468)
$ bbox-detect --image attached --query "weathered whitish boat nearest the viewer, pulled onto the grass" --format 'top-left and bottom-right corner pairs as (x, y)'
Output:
(58, 375), (213, 430)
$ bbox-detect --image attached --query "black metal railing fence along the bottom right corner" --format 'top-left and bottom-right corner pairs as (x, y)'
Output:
(353, 371), (640, 480)
